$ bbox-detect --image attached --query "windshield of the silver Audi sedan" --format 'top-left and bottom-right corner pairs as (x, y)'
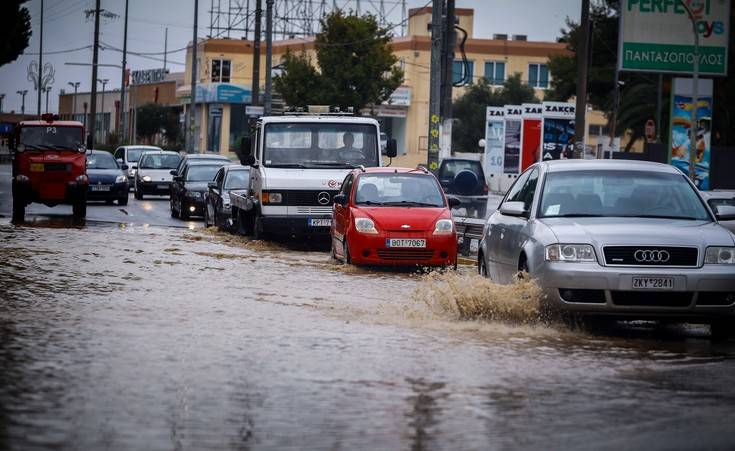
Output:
(538, 171), (712, 221)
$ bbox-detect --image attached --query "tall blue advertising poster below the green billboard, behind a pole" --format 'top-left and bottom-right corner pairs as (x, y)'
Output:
(671, 78), (712, 190)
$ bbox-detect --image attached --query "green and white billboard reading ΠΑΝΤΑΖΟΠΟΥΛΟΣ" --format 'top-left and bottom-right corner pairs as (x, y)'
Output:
(618, 0), (730, 75)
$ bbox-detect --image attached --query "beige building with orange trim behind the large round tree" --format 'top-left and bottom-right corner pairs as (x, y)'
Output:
(177, 8), (606, 165)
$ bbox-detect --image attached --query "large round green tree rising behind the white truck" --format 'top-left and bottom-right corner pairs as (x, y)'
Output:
(274, 10), (403, 111)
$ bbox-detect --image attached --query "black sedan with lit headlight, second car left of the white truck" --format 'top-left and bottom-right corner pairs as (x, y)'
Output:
(171, 161), (226, 220)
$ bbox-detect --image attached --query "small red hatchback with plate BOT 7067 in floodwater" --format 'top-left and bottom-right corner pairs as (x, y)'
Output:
(331, 167), (460, 266)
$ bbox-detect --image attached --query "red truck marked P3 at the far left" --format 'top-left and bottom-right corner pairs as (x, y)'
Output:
(10, 114), (89, 222)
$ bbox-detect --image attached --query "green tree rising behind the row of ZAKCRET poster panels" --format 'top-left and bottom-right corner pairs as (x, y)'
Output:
(452, 73), (539, 152)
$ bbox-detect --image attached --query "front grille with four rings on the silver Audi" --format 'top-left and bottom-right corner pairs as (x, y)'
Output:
(602, 246), (699, 267)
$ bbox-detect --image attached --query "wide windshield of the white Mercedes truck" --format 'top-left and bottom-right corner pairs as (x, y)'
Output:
(263, 123), (379, 168)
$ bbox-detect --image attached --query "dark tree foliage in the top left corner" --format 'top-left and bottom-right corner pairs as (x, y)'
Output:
(0, 0), (31, 66)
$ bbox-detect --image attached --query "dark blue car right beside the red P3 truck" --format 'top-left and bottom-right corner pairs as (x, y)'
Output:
(87, 150), (128, 205)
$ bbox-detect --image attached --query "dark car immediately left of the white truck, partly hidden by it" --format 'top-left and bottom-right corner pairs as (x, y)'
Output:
(204, 164), (250, 229)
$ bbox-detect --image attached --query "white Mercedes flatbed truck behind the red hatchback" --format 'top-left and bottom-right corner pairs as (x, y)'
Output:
(230, 114), (396, 239)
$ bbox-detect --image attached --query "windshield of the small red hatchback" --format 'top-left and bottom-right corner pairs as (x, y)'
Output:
(355, 173), (445, 208)
